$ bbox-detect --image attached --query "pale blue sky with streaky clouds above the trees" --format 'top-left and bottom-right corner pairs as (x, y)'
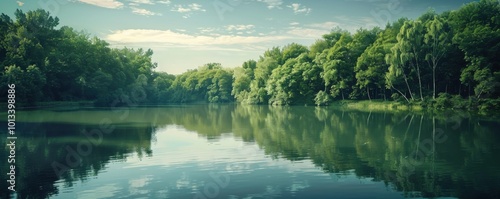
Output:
(0, 0), (472, 74)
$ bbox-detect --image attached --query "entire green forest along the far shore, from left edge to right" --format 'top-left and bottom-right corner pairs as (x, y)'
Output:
(0, 0), (500, 109)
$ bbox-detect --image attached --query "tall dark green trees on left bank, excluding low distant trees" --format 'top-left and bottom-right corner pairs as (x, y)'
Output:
(0, 10), (161, 103)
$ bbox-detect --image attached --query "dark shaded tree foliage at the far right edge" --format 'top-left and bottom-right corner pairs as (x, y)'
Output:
(450, 0), (500, 98)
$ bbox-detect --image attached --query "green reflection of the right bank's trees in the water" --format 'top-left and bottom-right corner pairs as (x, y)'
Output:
(188, 106), (500, 198)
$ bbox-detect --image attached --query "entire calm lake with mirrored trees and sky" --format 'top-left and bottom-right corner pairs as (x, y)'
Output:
(0, 105), (500, 199)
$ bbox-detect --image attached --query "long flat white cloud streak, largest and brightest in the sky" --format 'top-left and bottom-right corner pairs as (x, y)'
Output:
(106, 29), (289, 46)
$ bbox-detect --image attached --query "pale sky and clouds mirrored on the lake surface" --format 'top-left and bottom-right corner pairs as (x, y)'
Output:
(54, 126), (401, 198)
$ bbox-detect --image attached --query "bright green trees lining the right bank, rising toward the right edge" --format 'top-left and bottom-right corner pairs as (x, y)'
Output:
(233, 0), (500, 108)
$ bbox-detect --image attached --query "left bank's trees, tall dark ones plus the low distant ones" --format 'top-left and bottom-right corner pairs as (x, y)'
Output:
(0, 9), (234, 106)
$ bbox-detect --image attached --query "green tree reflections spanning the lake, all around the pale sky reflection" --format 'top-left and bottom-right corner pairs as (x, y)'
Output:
(0, 105), (500, 198)
